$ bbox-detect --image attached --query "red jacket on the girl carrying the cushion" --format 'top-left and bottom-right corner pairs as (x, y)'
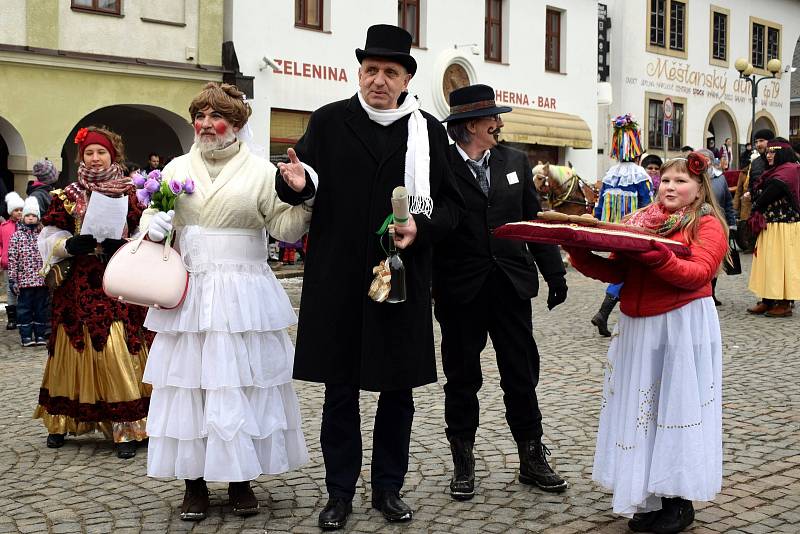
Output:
(570, 216), (728, 317)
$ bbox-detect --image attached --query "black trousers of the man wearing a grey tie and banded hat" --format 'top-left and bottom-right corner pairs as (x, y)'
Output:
(435, 269), (542, 442)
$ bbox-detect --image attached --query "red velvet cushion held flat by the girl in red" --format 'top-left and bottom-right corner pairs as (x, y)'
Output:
(494, 221), (690, 256)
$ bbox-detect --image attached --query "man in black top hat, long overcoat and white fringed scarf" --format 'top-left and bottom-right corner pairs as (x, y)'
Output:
(276, 25), (463, 529)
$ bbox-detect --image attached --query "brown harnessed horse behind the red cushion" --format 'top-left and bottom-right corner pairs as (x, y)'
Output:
(533, 161), (597, 215)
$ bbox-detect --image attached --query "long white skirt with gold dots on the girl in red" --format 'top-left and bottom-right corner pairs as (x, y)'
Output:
(592, 297), (722, 516)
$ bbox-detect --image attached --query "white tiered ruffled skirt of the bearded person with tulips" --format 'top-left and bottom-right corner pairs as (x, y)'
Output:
(143, 226), (308, 482)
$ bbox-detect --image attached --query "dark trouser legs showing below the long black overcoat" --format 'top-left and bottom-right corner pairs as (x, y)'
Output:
(320, 384), (414, 500)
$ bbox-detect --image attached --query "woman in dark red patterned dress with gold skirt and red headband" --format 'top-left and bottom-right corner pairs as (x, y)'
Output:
(34, 126), (152, 458)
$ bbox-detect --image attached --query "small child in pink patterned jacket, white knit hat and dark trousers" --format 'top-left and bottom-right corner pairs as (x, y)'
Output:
(8, 197), (49, 347)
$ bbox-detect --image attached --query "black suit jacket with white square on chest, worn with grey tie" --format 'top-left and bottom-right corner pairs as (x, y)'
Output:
(433, 145), (565, 303)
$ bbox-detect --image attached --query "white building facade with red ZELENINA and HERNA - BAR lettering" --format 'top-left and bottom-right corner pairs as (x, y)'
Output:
(224, 0), (597, 176)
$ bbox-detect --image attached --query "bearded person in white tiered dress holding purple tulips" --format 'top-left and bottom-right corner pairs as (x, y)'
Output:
(142, 83), (313, 521)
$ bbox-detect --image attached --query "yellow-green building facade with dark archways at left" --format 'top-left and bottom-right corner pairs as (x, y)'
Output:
(0, 0), (224, 192)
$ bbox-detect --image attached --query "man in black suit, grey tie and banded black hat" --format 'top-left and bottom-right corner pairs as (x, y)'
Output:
(433, 85), (567, 500)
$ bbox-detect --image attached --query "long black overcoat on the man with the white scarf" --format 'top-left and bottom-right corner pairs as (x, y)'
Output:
(275, 96), (463, 391)
